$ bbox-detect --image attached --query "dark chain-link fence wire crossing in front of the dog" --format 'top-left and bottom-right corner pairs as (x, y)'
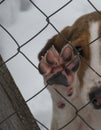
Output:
(0, 0), (101, 130)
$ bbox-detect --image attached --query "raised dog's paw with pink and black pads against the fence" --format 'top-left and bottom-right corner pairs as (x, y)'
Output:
(39, 44), (80, 86)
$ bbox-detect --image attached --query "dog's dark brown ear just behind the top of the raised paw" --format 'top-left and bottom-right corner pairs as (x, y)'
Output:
(38, 26), (71, 60)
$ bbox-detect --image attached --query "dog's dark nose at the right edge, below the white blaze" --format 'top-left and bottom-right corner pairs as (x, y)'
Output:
(89, 87), (101, 109)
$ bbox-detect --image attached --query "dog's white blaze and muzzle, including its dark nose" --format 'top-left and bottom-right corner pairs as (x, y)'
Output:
(79, 22), (101, 109)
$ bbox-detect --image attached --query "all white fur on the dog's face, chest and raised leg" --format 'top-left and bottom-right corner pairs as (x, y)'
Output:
(48, 22), (101, 130)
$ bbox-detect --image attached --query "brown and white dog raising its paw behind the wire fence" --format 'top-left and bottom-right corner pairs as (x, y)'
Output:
(38, 12), (101, 130)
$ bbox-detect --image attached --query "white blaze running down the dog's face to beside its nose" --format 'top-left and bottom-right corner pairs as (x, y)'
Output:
(81, 22), (101, 103)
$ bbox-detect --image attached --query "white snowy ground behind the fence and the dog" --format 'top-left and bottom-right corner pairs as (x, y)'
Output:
(0, 0), (101, 130)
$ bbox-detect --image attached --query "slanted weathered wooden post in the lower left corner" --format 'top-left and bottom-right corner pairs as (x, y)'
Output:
(0, 56), (40, 130)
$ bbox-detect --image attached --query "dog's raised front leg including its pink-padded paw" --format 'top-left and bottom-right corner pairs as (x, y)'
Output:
(39, 44), (79, 130)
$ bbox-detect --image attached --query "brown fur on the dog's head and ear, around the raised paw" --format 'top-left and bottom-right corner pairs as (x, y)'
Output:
(38, 12), (101, 86)
